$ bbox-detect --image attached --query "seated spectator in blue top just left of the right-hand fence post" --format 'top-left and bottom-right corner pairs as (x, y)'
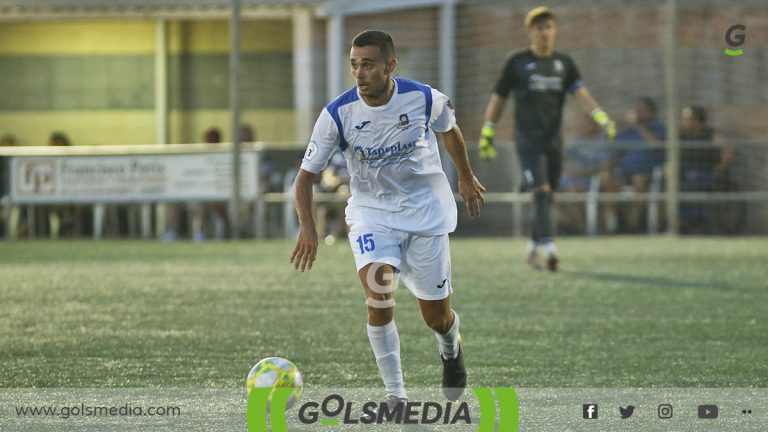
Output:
(616, 97), (667, 232)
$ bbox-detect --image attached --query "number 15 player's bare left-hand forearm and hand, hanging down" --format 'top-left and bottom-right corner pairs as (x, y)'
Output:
(291, 169), (317, 272)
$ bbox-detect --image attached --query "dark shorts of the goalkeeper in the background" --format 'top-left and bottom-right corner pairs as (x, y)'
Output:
(515, 133), (563, 192)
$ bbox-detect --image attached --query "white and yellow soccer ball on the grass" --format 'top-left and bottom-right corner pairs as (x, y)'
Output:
(246, 357), (304, 409)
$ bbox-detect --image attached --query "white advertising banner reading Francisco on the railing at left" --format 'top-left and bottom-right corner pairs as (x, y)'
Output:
(10, 152), (257, 204)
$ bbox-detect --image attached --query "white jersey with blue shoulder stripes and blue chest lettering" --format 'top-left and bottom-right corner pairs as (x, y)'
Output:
(301, 78), (456, 235)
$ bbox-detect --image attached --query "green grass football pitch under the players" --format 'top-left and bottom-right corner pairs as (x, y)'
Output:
(0, 237), (768, 388)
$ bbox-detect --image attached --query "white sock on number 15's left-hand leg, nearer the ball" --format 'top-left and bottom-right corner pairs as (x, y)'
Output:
(368, 320), (408, 398)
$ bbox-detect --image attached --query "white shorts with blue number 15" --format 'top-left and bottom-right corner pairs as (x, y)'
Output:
(348, 220), (453, 300)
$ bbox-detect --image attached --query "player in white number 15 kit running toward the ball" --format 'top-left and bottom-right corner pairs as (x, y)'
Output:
(291, 30), (485, 403)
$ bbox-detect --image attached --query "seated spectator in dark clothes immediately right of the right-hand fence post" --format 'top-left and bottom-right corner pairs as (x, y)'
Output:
(680, 106), (734, 234)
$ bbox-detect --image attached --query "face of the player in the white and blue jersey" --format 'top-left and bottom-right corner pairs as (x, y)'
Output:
(349, 45), (396, 100)
